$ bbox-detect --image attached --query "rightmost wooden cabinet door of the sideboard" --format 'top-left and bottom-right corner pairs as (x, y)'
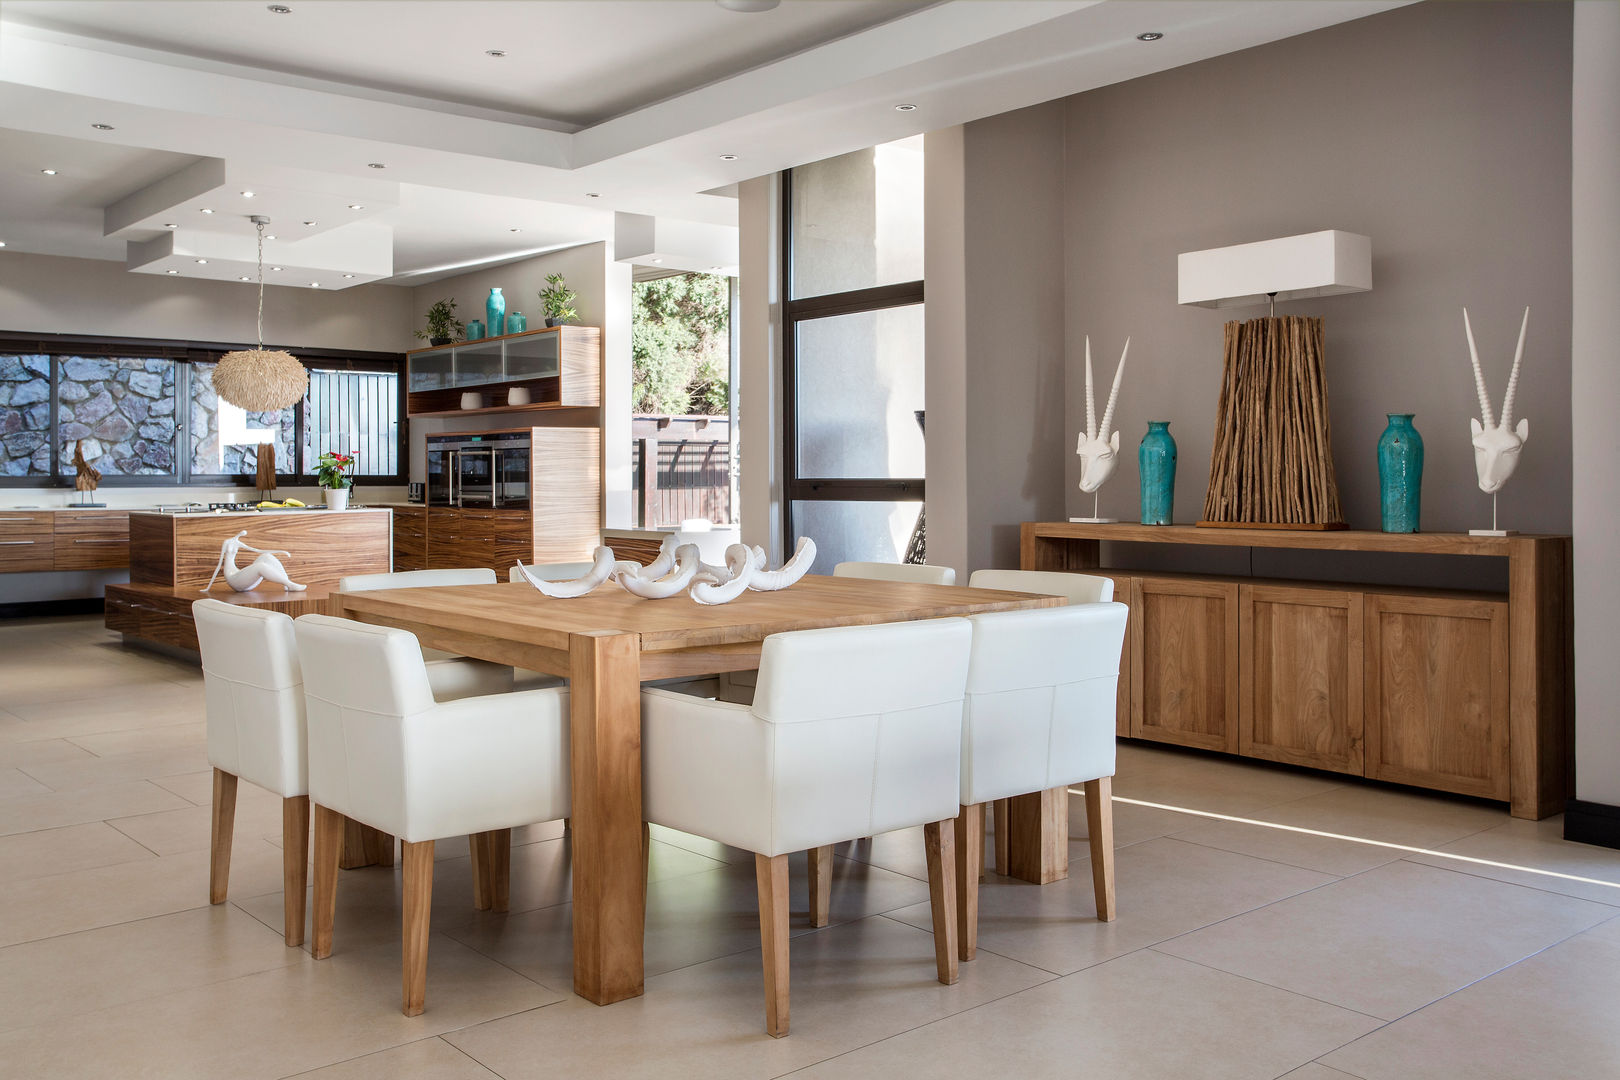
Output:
(1366, 593), (1508, 798)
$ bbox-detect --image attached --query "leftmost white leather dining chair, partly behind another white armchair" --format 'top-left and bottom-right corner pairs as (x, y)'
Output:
(191, 599), (510, 946)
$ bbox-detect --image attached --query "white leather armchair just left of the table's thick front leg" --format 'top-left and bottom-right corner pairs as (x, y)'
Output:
(293, 615), (569, 1017)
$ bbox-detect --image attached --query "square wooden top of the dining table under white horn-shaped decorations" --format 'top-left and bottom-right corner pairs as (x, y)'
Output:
(337, 575), (1063, 678)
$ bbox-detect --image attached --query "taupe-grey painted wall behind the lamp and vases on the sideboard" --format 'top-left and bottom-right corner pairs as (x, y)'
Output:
(1062, 3), (1571, 533)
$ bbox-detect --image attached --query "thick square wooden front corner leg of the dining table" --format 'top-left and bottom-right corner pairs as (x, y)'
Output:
(569, 630), (646, 1006)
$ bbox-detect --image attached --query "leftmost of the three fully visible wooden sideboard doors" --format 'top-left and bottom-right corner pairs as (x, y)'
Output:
(1129, 576), (1238, 753)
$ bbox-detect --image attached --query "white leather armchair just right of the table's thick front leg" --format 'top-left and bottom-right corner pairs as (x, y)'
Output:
(642, 619), (972, 1036)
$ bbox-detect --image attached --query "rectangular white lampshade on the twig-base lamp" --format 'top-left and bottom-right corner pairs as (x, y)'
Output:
(1176, 228), (1372, 308)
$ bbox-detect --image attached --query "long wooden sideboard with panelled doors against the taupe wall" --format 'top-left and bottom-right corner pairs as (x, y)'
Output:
(1021, 521), (1573, 818)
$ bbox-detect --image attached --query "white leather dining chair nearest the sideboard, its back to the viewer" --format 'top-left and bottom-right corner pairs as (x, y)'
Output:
(956, 604), (1126, 960)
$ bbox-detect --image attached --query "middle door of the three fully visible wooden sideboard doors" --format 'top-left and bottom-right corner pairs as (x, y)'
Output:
(1238, 585), (1362, 776)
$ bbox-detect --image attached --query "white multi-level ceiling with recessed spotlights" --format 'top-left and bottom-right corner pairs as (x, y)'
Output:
(0, 0), (1405, 287)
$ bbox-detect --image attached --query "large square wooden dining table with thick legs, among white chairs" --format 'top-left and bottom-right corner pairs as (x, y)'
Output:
(337, 575), (1063, 1006)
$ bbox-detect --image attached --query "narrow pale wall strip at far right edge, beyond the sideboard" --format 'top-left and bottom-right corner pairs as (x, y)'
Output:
(1571, 0), (1620, 806)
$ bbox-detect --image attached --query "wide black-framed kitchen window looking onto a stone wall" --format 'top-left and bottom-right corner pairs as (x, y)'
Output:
(0, 335), (405, 487)
